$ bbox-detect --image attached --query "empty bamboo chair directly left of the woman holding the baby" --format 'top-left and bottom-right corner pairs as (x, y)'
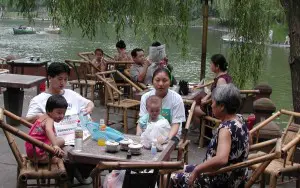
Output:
(96, 70), (142, 133)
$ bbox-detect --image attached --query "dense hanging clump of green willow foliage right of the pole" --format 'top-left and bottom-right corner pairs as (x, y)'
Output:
(228, 0), (272, 88)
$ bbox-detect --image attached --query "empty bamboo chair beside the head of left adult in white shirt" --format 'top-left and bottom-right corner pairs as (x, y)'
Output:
(65, 59), (101, 102)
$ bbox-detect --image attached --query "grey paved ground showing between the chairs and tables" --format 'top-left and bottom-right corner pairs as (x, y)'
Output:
(0, 88), (295, 188)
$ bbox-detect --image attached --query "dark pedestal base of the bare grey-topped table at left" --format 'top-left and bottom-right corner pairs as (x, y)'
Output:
(3, 87), (24, 126)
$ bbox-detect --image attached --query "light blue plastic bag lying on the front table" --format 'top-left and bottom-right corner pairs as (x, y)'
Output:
(86, 122), (124, 142)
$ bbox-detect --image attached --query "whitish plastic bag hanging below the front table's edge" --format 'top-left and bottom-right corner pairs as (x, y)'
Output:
(103, 170), (126, 188)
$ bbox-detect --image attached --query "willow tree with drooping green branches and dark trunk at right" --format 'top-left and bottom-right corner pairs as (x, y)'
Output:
(10, 0), (300, 112)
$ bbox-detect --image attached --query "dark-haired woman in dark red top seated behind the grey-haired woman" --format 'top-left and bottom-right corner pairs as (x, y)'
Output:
(193, 54), (232, 127)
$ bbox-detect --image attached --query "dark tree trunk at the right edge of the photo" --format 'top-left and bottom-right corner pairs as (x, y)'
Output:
(281, 0), (300, 123)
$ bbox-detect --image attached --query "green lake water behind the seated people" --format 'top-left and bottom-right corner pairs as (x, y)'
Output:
(0, 20), (292, 115)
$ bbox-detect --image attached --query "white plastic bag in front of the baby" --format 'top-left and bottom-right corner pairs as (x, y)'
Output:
(141, 119), (171, 148)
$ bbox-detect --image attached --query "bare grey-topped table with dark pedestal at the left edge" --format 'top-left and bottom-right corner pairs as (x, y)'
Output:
(0, 74), (46, 125)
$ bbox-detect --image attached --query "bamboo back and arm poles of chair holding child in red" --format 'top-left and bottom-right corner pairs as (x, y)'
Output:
(0, 108), (59, 168)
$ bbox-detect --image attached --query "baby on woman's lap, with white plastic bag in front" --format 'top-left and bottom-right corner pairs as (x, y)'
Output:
(137, 95), (171, 143)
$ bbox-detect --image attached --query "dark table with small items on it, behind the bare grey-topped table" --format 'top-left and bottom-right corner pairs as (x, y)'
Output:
(7, 57), (50, 87)
